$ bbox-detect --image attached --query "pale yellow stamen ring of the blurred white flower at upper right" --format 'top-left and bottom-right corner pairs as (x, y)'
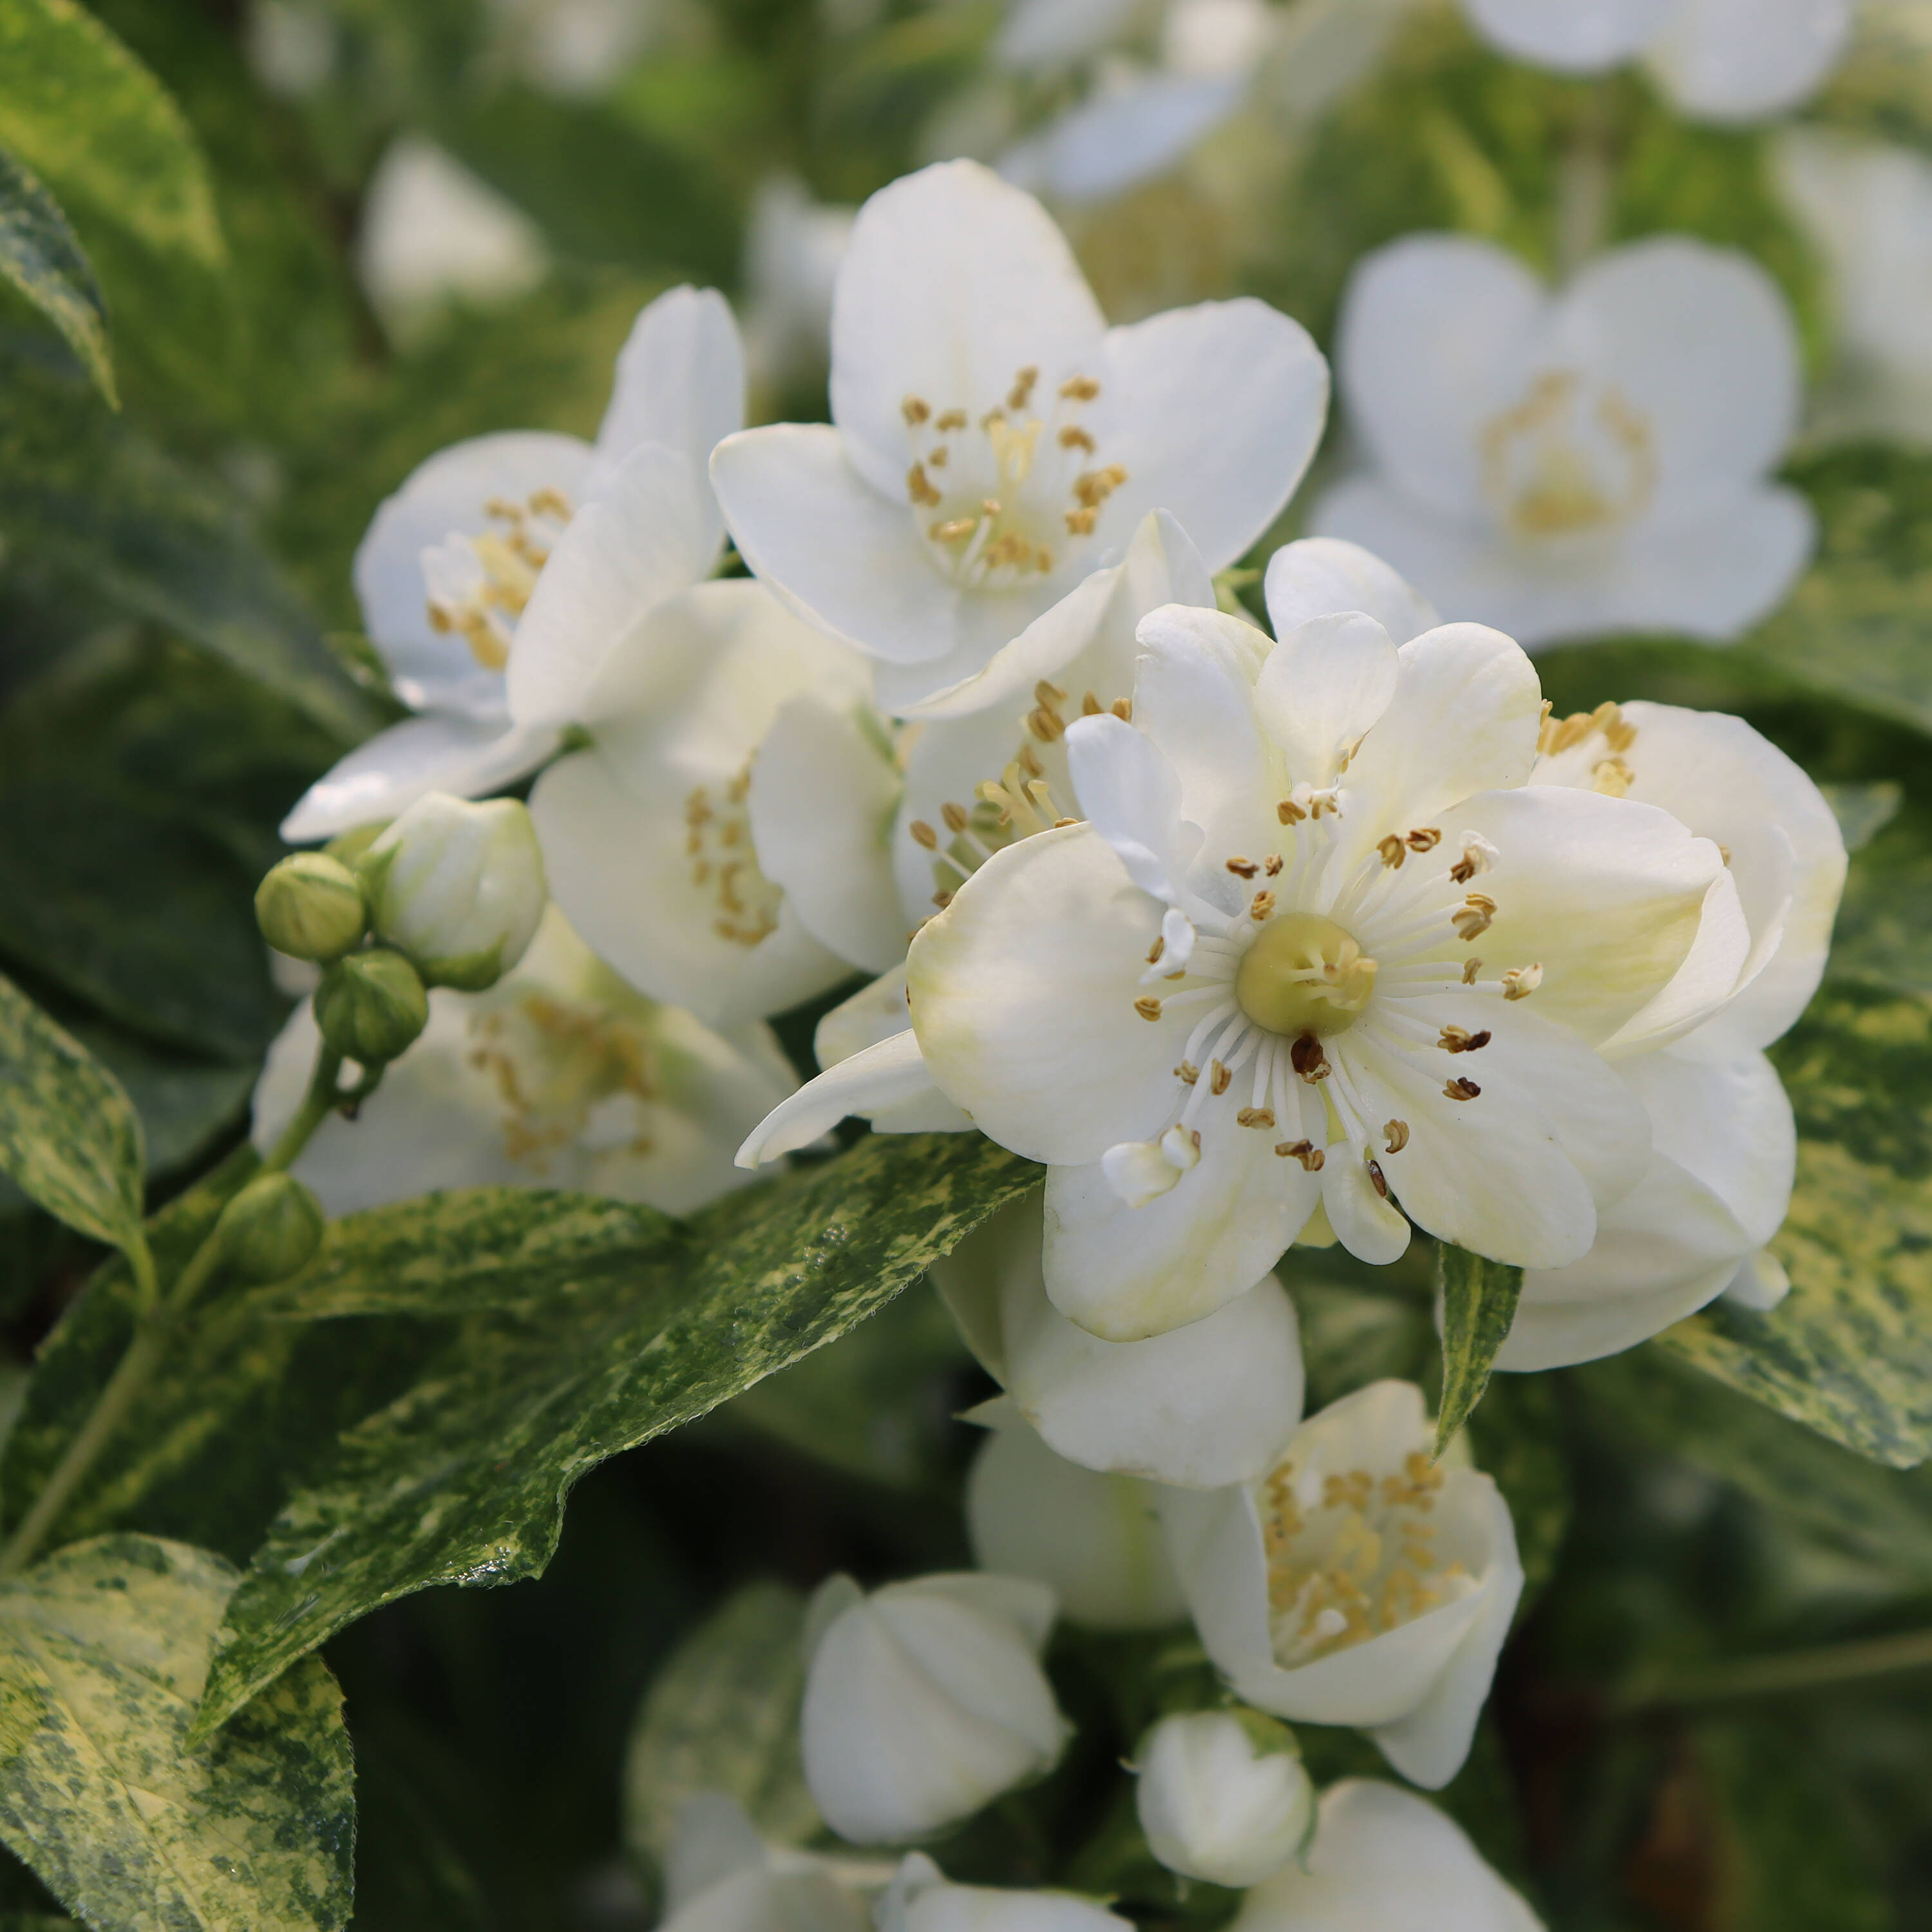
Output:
(1482, 369), (1658, 543)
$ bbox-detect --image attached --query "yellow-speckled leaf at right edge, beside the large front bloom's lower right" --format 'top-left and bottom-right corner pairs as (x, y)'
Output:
(1660, 987), (1932, 1468)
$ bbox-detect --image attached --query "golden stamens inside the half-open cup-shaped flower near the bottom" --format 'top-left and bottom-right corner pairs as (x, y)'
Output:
(1262, 1449), (1476, 1669)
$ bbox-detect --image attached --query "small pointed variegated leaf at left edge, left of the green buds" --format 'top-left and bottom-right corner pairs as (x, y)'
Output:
(0, 978), (141, 1248)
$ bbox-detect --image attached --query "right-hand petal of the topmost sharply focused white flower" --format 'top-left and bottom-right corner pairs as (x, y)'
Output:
(1105, 298), (1329, 570)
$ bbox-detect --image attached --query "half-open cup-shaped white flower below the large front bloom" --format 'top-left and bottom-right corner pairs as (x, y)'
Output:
(1161, 1381), (1522, 1791)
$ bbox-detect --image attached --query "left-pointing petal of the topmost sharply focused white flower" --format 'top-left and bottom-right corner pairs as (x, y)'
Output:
(711, 423), (962, 665)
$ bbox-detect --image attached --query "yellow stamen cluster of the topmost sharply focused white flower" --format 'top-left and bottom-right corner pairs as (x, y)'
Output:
(900, 367), (1126, 589)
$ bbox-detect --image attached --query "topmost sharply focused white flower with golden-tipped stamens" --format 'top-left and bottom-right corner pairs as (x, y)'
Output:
(711, 162), (1327, 715)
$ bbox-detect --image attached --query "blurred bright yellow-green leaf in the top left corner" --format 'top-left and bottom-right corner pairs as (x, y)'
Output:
(0, 0), (222, 269)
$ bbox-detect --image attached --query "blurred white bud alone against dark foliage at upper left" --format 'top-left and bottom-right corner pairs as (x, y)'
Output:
(355, 133), (549, 340)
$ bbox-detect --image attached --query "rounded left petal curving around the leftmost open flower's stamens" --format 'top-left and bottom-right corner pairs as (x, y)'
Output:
(355, 429), (591, 717)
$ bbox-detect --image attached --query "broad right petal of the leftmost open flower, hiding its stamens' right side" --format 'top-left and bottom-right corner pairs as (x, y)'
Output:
(508, 442), (717, 724)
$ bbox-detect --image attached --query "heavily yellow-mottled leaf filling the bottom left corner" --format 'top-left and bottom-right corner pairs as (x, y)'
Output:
(0, 1536), (355, 1932)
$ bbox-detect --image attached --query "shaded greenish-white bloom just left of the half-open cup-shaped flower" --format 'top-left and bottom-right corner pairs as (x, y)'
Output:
(966, 1414), (1188, 1631)
